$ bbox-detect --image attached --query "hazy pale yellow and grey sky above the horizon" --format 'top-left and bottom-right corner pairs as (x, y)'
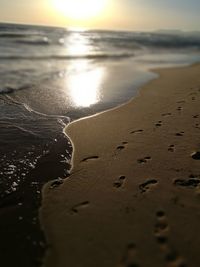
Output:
(0, 0), (200, 30)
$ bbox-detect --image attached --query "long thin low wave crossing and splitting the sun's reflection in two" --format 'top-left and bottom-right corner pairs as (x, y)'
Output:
(0, 53), (134, 60)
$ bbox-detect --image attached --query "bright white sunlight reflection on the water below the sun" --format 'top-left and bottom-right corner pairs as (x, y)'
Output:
(66, 32), (105, 107)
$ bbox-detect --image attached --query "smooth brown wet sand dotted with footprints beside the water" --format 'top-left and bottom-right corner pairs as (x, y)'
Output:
(40, 65), (200, 267)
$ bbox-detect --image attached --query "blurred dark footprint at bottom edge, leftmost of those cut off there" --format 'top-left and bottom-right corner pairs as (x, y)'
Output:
(120, 243), (139, 267)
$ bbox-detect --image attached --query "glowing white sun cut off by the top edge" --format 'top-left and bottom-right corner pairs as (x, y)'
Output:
(53, 0), (107, 21)
